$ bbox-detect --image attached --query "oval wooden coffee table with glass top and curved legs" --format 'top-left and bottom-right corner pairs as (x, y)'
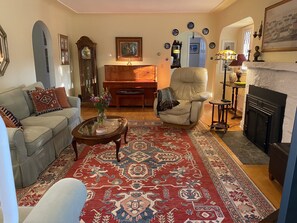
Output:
(72, 116), (128, 162)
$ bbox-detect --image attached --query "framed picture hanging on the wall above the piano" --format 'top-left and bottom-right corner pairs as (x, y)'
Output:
(116, 37), (142, 61)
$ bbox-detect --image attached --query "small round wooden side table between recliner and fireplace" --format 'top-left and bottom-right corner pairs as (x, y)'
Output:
(209, 100), (231, 132)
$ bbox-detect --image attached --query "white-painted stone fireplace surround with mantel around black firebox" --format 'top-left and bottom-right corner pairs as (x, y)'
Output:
(240, 62), (297, 142)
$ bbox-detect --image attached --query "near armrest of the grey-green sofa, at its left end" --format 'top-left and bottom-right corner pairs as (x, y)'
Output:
(6, 128), (28, 162)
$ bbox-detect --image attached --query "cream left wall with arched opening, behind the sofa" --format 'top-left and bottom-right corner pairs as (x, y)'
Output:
(0, 0), (73, 91)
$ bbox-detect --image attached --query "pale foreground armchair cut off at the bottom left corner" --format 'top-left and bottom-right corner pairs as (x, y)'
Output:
(0, 117), (87, 223)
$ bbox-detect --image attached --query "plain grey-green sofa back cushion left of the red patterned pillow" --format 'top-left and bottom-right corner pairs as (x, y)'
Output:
(0, 88), (30, 120)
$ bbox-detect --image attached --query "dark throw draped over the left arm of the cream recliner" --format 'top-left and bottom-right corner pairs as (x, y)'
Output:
(157, 87), (179, 111)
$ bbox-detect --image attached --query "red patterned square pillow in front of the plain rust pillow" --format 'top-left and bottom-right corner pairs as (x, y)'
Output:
(29, 89), (62, 115)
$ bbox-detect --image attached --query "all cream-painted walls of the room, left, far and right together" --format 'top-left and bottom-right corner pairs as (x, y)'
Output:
(0, 0), (296, 100)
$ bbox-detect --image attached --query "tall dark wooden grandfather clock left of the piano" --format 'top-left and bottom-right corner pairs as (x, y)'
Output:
(76, 36), (99, 102)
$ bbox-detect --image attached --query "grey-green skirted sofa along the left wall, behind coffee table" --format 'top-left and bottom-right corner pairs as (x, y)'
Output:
(0, 82), (81, 188)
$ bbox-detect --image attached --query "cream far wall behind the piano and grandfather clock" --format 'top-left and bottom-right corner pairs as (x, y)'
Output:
(72, 14), (217, 96)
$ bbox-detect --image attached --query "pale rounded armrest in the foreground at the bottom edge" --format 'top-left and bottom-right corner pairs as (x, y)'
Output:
(24, 178), (87, 223)
